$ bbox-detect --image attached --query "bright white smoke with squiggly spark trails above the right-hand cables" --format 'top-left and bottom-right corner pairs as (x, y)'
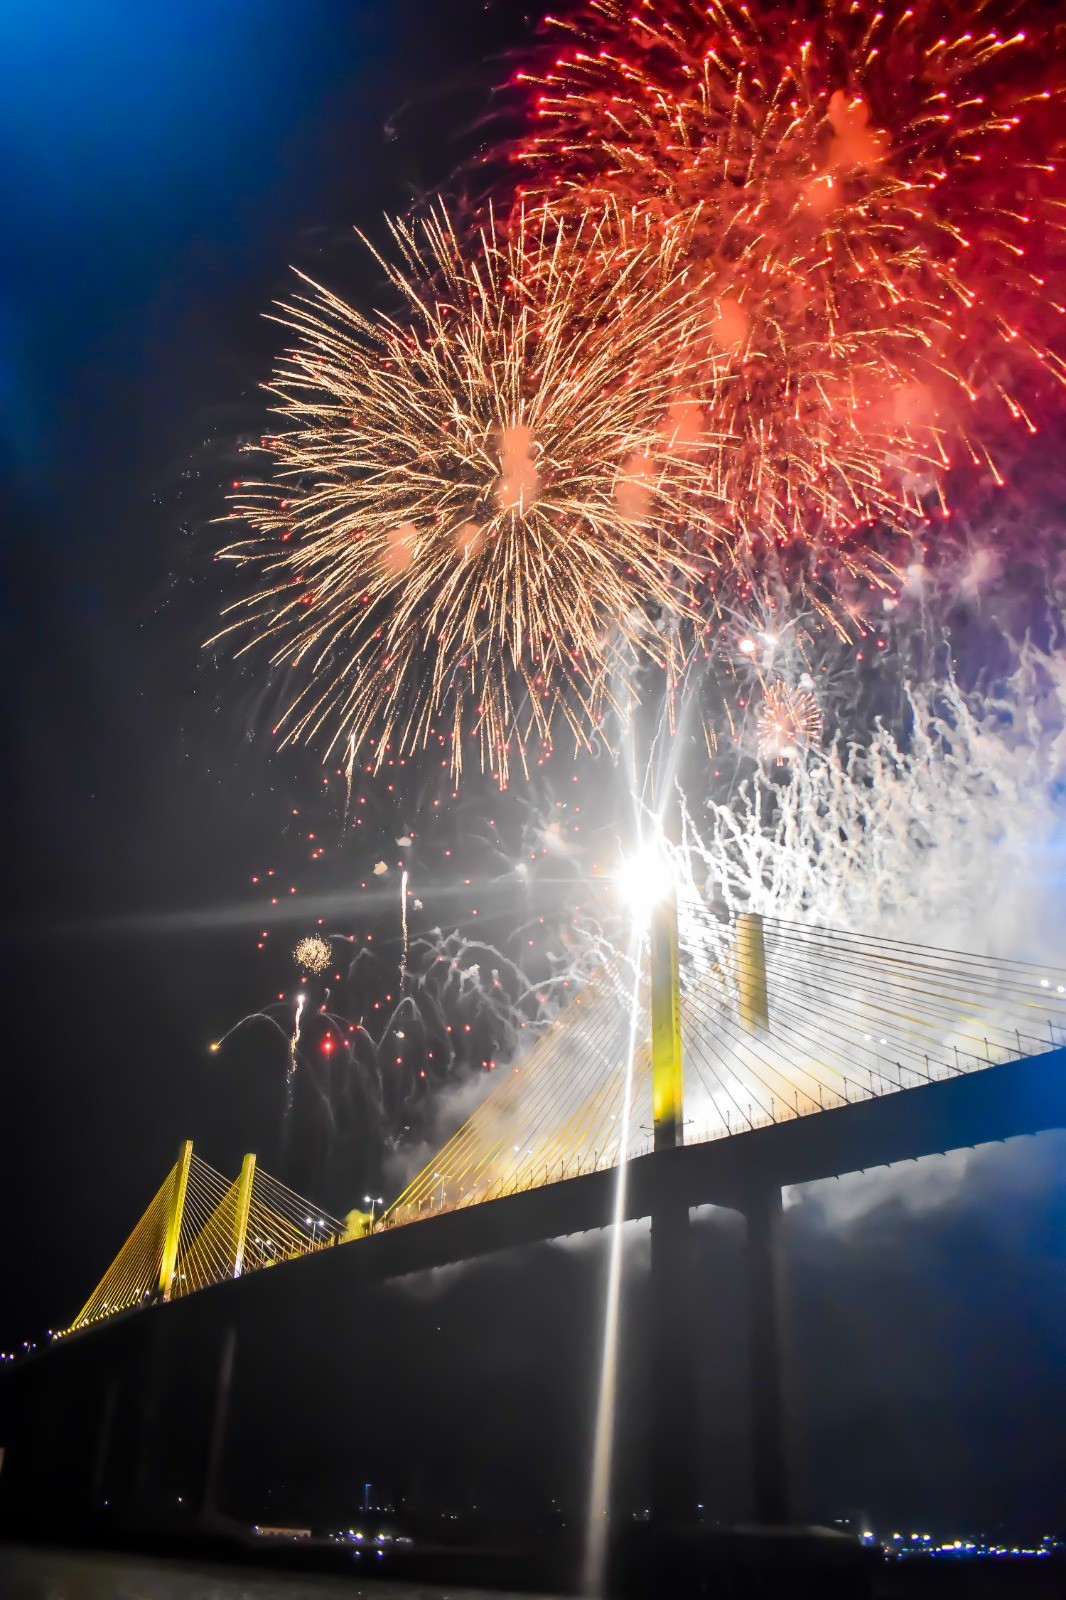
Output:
(685, 642), (1066, 960)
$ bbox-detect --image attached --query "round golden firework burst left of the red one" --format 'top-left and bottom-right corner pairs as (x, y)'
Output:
(211, 214), (717, 781)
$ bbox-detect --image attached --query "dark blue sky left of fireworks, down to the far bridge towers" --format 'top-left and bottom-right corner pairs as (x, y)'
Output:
(0, 0), (525, 1324)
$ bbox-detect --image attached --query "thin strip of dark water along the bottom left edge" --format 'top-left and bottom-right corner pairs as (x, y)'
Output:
(0, 1546), (518, 1600)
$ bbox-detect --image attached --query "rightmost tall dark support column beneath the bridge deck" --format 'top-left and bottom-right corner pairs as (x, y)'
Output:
(744, 1184), (789, 1526)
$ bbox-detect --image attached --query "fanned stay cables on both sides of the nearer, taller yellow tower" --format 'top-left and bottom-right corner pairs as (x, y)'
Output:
(383, 901), (1066, 1226)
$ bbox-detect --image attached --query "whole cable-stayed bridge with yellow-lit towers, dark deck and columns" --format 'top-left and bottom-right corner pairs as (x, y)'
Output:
(8, 896), (1066, 1522)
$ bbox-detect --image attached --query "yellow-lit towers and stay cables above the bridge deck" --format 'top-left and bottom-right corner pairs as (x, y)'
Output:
(52, 898), (1066, 1333)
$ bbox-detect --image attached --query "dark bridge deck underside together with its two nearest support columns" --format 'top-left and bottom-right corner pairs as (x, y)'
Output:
(217, 1048), (1066, 1525)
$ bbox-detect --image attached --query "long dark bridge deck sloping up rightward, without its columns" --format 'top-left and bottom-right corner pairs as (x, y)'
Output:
(235, 1048), (1066, 1294)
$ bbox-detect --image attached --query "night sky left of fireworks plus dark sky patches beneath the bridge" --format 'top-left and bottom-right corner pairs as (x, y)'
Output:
(0, 0), (1066, 1533)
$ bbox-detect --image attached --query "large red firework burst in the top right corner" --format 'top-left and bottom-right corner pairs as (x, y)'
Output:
(519, 0), (1066, 565)
